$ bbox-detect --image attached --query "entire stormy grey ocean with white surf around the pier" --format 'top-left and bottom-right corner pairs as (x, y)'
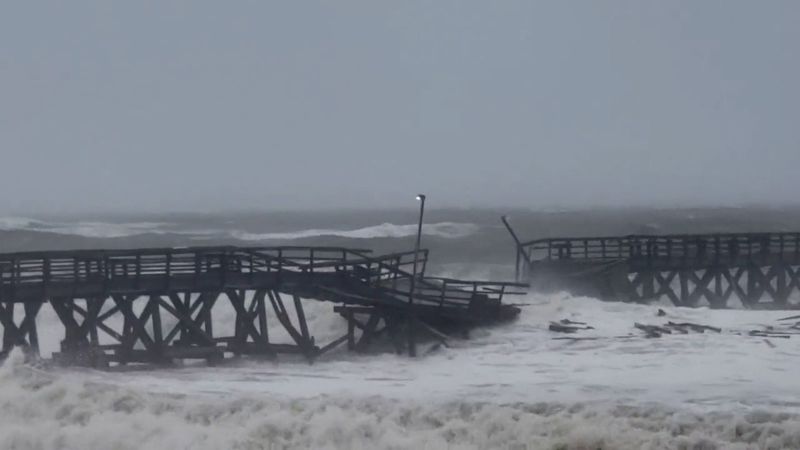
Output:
(0, 207), (800, 450)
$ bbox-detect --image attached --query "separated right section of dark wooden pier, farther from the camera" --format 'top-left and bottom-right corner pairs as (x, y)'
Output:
(517, 233), (800, 309)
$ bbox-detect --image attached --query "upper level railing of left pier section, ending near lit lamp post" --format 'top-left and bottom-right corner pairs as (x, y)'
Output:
(0, 247), (428, 288)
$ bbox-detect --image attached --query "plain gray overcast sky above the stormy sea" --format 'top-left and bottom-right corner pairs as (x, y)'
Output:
(0, 0), (800, 213)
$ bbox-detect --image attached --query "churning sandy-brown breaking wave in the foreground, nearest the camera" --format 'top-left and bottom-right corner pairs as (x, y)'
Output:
(0, 352), (800, 450)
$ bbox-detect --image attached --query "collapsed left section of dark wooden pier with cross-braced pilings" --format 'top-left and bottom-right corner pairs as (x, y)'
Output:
(0, 247), (525, 366)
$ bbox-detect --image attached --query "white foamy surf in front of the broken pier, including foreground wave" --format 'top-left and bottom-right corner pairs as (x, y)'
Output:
(0, 295), (800, 450)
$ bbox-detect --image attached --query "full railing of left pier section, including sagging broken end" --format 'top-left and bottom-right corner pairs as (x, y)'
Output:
(0, 247), (526, 316)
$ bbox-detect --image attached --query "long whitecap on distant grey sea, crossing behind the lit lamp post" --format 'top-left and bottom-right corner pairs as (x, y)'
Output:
(231, 222), (480, 241)
